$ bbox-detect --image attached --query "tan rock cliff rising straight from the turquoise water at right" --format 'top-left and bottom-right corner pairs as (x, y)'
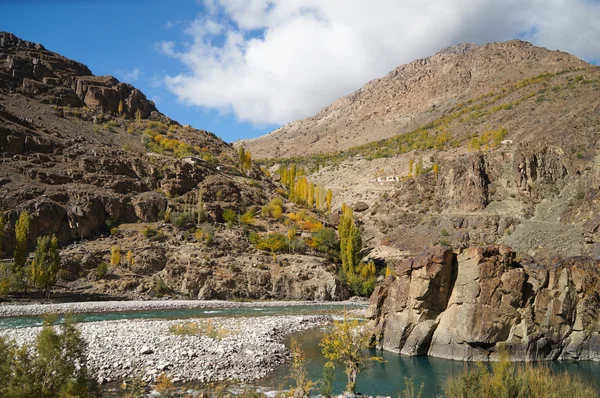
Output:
(368, 246), (600, 361)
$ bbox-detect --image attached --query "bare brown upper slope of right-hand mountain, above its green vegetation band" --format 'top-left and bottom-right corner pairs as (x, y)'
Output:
(244, 40), (591, 158)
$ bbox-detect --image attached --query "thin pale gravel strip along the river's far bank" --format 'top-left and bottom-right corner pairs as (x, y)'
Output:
(0, 300), (368, 318)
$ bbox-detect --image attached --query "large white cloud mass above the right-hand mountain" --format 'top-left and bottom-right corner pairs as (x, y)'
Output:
(157, 0), (600, 125)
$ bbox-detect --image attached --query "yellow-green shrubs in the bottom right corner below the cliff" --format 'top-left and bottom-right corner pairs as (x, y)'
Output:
(444, 360), (597, 398)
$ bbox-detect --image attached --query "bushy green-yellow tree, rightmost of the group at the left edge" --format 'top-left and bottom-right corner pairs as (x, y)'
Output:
(30, 235), (60, 298)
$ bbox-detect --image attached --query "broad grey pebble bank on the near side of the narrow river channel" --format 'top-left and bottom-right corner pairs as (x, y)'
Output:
(0, 315), (332, 383)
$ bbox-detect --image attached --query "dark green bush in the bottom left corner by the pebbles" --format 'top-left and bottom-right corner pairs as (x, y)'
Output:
(0, 320), (100, 398)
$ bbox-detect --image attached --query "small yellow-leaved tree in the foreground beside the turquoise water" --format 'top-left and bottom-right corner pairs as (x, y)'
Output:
(319, 314), (381, 394)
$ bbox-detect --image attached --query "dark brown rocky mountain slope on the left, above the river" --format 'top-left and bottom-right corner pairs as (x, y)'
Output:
(0, 32), (346, 299)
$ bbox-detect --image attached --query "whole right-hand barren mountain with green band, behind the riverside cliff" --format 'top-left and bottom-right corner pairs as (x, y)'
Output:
(244, 41), (600, 264)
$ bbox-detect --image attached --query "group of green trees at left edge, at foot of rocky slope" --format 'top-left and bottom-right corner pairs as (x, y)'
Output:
(0, 211), (60, 298)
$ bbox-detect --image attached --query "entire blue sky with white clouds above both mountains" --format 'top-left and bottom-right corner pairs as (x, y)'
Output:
(0, 0), (600, 142)
